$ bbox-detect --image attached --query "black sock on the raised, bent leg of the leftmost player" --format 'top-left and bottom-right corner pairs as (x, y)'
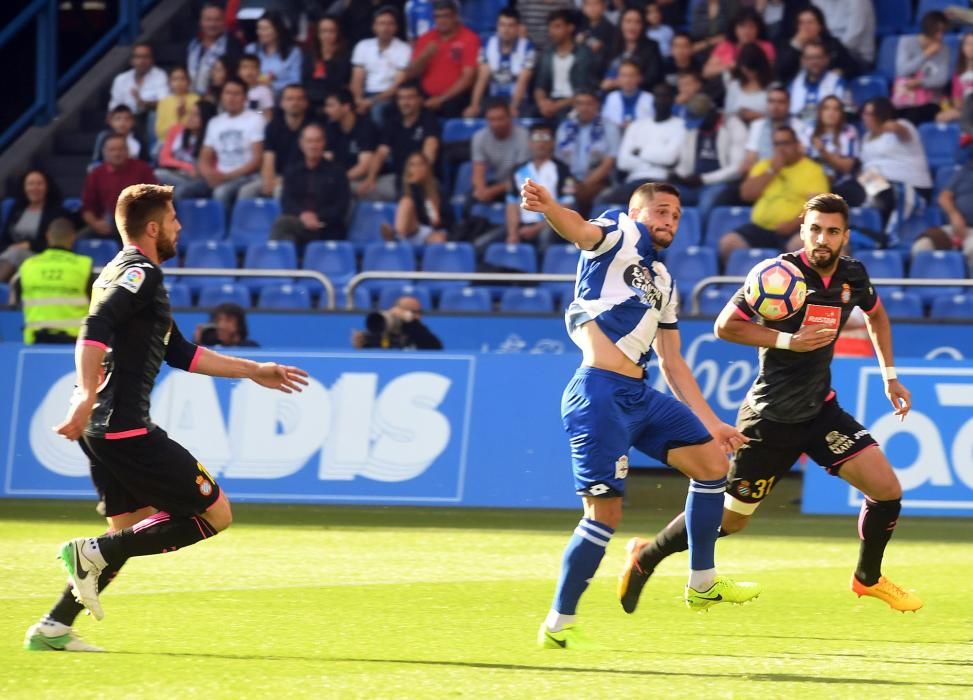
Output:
(98, 511), (216, 565)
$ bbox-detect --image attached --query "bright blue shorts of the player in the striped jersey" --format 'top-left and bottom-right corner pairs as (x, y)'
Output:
(561, 367), (713, 497)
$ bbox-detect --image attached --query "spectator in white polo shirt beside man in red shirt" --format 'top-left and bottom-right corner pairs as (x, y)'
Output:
(350, 6), (412, 125)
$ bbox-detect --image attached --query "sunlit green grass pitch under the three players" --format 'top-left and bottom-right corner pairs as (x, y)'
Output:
(0, 477), (973, 700)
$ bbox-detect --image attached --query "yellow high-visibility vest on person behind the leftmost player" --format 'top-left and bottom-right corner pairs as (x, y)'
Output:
(20, 248), (91, 345)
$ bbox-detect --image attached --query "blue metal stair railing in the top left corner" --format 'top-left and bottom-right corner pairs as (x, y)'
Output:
(0, 0), (156, 150)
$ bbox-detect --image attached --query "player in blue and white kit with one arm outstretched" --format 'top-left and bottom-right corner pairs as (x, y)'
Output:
(521, 180), (760, 649)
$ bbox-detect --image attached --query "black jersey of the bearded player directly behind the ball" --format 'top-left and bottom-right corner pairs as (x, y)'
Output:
(731, 251), (879, 423)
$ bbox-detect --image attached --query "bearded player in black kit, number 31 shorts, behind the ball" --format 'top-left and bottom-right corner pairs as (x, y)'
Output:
(618, 194), (922, 613)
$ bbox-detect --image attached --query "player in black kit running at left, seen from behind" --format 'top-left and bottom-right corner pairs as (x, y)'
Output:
(25, 185), (307, 651)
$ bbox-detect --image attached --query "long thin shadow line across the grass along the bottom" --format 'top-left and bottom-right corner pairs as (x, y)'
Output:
(109, 650), (973, 688)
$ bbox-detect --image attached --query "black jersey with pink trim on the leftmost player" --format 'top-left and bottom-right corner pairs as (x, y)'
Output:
(79, 246), (199, 439)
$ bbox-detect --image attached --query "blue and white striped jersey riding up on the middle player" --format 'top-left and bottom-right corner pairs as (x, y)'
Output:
(564, 209), (679, 366)
